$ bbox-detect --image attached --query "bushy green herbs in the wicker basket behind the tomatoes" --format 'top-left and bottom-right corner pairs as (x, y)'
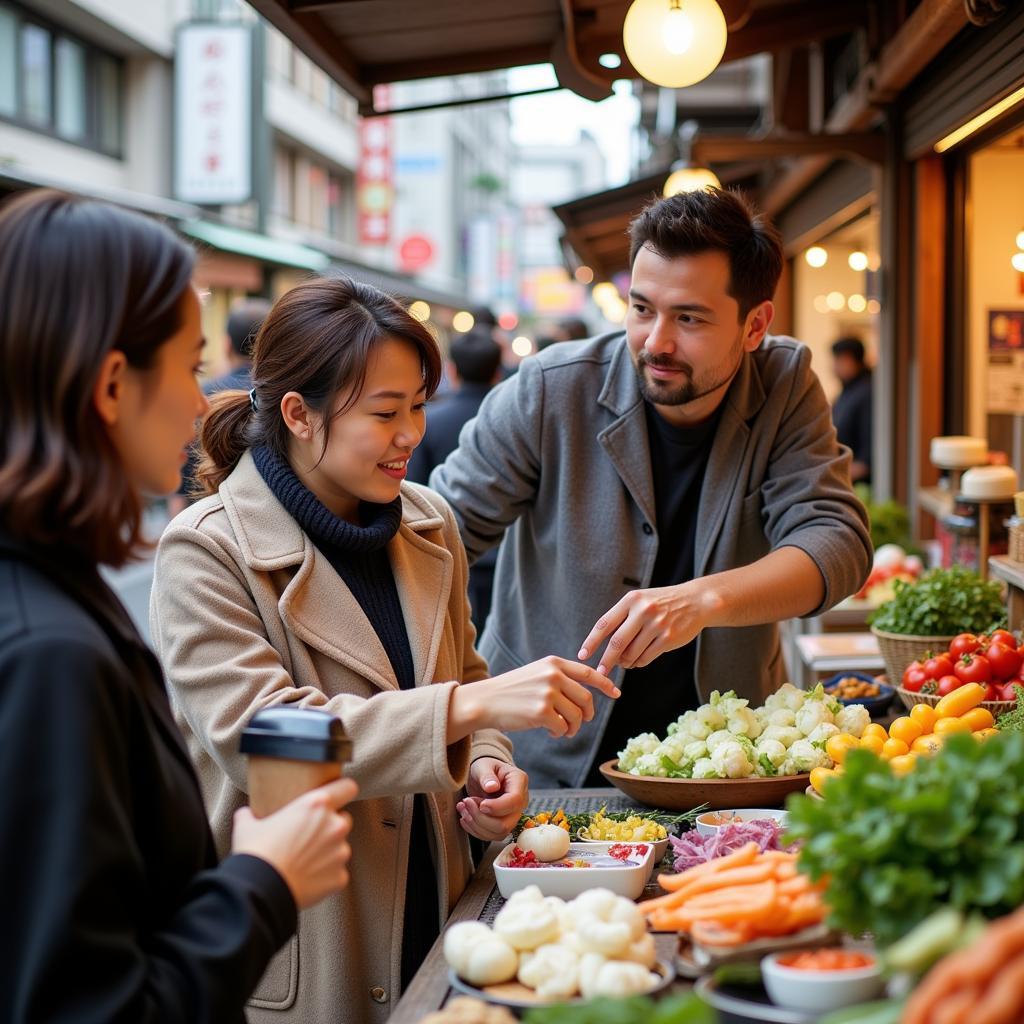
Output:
(868, 565), (1006, 637)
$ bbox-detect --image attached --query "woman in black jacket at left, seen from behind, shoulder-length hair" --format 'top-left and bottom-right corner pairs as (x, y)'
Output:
(0, 191), (355, 1024)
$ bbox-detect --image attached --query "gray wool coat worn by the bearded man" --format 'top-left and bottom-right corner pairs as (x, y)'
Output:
(430, 331), (871, 787)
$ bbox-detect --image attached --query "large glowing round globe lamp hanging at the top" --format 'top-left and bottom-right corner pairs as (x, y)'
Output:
(623, 0), (728, 89)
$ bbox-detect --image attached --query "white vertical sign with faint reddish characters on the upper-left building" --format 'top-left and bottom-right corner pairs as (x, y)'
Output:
(174, 24), (253, 204)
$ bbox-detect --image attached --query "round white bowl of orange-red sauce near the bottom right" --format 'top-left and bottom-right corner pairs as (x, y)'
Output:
(761, 947), (885, 1013)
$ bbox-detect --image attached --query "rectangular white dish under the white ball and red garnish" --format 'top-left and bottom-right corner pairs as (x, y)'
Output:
(495, 842), (653, 899)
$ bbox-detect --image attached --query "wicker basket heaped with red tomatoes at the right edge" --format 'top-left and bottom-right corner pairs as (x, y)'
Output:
(896, 630), (1024, 717)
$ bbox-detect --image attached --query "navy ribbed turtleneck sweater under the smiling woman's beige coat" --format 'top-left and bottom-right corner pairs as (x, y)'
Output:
(252, 446), (440, 988)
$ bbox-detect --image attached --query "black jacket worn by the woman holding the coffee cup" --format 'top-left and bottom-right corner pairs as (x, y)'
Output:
(0, 530), (297, 1024)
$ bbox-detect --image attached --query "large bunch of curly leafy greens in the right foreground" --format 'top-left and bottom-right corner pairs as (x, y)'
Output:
(786, 733), (1024, 946)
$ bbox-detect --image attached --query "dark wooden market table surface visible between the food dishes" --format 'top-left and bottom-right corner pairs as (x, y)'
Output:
(388, 788), (691, 1024)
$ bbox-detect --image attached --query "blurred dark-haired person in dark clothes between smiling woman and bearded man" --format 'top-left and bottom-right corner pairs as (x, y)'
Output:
(409, 327), (502, 633)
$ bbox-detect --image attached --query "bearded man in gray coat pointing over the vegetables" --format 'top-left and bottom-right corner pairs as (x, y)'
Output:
(430, 189), (871, 786)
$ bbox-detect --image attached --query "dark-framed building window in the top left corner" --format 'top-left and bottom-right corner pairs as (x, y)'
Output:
(0, 0), (123, 157)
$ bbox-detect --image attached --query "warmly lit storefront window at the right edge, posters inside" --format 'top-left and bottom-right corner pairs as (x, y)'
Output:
(967, 126), (1024, 457)
